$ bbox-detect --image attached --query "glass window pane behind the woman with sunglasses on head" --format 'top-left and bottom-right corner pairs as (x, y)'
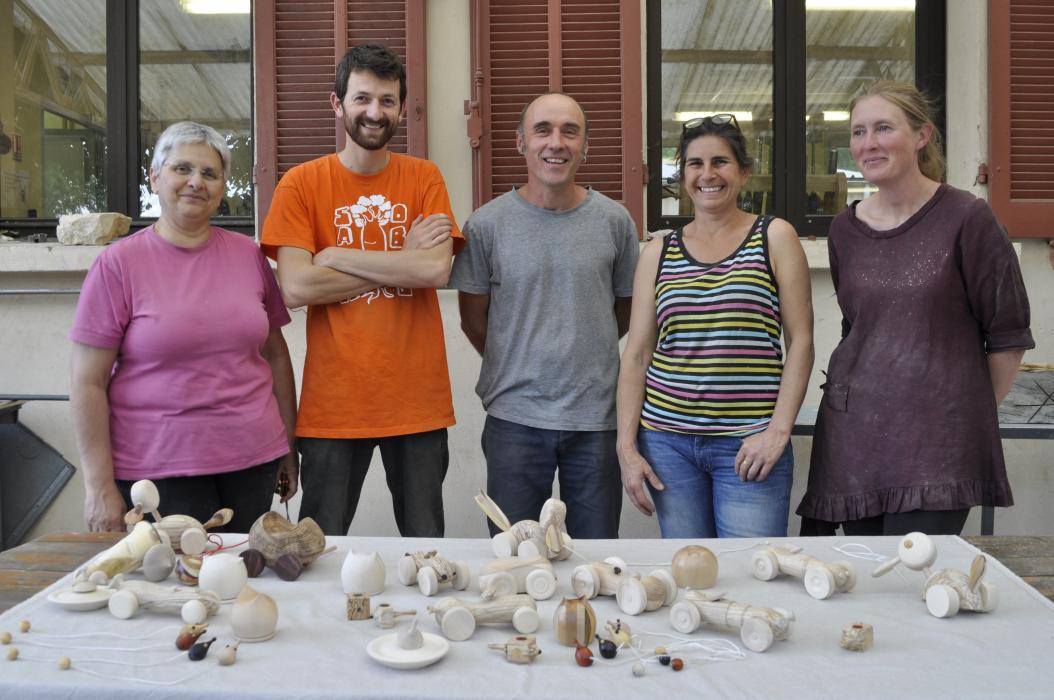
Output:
(661, 0), (774, 216)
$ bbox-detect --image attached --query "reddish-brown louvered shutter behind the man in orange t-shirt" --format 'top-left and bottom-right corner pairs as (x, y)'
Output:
(253, 0), (427, 222)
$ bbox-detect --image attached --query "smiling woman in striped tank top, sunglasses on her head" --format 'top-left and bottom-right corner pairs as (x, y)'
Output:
(618, 114), (813, 538)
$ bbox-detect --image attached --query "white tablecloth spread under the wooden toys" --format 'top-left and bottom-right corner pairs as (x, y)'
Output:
(0, 534), (1054, 700)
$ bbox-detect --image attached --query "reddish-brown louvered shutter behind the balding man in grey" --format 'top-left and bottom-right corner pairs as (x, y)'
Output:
(468, 0), (644, 231)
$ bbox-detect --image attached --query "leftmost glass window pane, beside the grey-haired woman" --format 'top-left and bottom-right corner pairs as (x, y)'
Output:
(0, 0), (106, 218)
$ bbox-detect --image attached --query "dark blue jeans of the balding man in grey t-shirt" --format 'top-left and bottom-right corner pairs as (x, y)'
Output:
(481, 415), (622, 540)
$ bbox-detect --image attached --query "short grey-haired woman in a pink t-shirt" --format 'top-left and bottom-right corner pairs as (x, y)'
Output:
(70, 121), (298, 532)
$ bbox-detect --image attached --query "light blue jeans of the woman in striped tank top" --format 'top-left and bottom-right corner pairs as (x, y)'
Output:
(637, 428), (794, 538)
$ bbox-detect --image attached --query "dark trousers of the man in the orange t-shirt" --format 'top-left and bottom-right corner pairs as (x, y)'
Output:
(297, 428), (450, 538)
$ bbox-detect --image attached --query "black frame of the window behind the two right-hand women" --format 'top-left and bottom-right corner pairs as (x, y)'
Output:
(645, 0), (946, 236)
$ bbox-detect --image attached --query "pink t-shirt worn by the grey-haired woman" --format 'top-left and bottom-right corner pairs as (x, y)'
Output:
(70, 226), (290, 480)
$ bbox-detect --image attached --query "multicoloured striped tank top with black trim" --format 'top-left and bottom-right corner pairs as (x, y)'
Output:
(641, 216), (783, 436)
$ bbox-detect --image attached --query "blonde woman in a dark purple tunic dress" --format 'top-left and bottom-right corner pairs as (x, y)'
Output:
(798, 81), (1034, 536)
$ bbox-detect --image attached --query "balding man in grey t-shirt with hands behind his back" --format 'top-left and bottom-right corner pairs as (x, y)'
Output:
(450, 93), (639, 539)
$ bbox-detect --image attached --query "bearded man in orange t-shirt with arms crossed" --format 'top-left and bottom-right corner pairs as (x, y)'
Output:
(261, 44), (464, 537)
